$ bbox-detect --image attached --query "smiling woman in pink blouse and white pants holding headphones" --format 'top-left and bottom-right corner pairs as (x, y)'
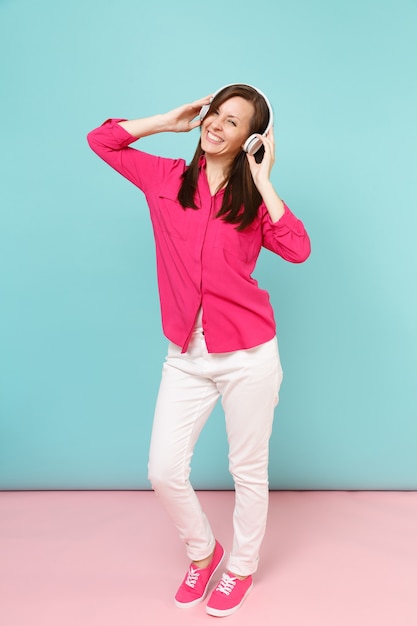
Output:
(88, 84), (310, 617)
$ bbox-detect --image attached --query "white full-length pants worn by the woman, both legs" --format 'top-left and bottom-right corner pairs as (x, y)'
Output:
(149, 329), (282, 576)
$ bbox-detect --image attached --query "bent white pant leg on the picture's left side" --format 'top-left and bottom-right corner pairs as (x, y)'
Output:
(149, 333), (219, 561)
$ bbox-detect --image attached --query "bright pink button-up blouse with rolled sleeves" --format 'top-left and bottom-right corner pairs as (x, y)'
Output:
(88, 119), (310, 353)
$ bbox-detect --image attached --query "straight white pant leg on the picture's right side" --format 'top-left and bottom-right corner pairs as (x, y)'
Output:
(217, 338), (282, 576)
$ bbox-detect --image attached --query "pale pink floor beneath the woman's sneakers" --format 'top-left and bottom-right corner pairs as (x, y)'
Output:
(0, 491), (417, 626)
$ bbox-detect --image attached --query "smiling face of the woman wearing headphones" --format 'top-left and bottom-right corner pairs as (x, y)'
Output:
(201, 96), (254, 159)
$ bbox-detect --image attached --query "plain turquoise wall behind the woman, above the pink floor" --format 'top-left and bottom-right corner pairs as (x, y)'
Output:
(0, 0), (417, 489)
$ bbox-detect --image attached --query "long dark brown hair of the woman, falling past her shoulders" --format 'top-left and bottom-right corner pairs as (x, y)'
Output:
(178, 84), (269, 230)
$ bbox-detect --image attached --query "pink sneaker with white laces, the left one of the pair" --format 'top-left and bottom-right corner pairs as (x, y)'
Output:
(175, 541), (224, 608)
